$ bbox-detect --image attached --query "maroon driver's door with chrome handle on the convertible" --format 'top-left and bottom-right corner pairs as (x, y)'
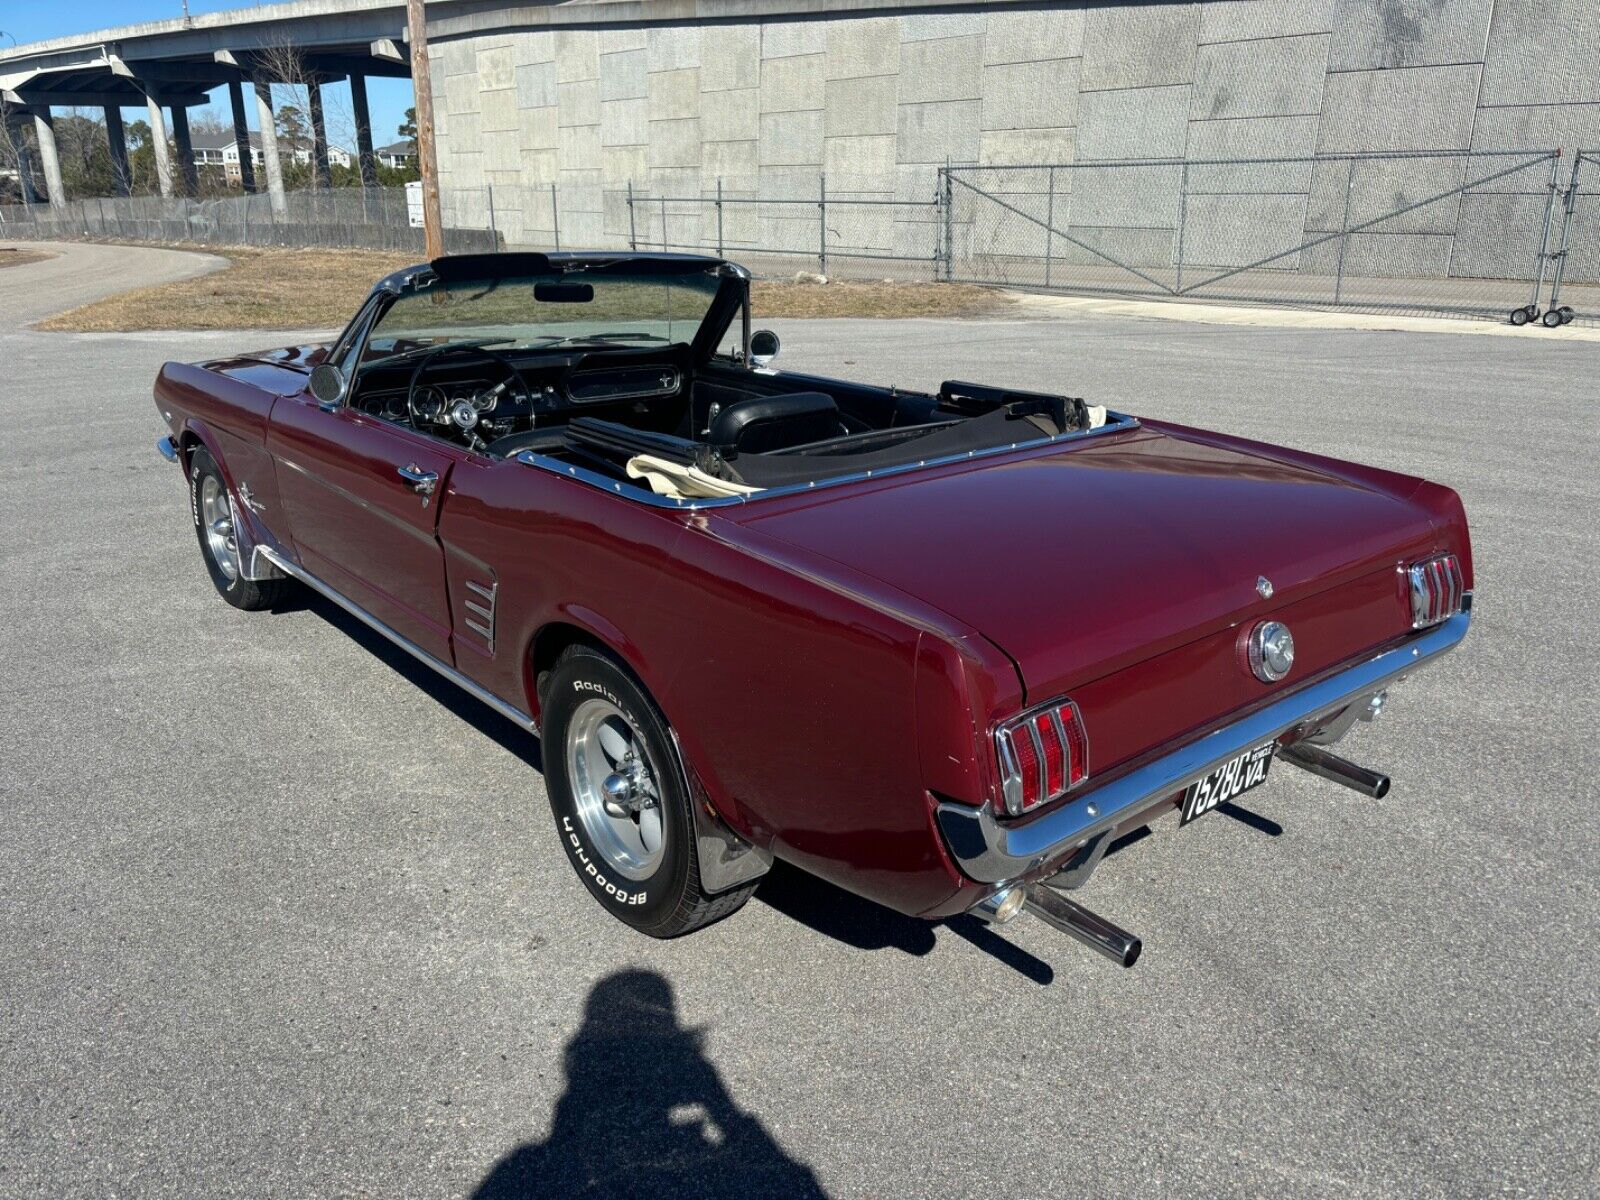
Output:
(267, 390), (467, 662)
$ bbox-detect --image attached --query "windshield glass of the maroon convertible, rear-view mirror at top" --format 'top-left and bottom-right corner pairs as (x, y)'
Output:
(363, 270), (718, 360)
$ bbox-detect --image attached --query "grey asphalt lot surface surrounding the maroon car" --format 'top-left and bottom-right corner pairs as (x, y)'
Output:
(0, 249), (1600, 1197)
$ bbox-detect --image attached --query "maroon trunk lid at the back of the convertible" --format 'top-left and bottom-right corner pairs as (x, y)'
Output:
(733, 424), (1434, 699)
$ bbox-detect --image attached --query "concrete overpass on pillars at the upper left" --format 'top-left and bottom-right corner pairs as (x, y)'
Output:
(0, 0), (411, 211)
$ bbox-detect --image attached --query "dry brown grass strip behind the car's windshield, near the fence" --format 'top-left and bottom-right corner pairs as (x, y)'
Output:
(34, 246), (1014, 333)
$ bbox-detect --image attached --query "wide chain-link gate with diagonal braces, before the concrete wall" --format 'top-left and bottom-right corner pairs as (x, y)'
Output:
(941, 150), (1563, 322)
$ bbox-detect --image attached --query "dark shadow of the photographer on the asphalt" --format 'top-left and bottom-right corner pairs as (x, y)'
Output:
(474, 970), (827, 1200)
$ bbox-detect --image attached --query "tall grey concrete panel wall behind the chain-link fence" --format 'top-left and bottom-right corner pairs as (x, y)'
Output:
(430, 0), (1600, 275)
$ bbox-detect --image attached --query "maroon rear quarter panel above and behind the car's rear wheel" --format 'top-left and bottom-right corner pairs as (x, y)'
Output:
(440, 462), (970, 912)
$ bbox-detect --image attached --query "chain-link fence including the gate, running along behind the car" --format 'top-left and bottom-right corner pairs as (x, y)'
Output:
(0, 150), (1600, 323)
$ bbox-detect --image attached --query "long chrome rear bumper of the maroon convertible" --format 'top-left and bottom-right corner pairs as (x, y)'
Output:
(936, 613), (1470, 883)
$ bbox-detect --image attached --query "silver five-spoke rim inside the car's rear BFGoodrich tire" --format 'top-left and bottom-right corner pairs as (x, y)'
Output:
(566, 696), (666, 880)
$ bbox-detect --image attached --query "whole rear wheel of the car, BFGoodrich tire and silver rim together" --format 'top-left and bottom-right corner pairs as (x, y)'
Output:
(542, 646), (755, 938)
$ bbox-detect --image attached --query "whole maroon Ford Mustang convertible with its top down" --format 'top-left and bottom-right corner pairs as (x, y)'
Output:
(155, 253), (1472, 965)
